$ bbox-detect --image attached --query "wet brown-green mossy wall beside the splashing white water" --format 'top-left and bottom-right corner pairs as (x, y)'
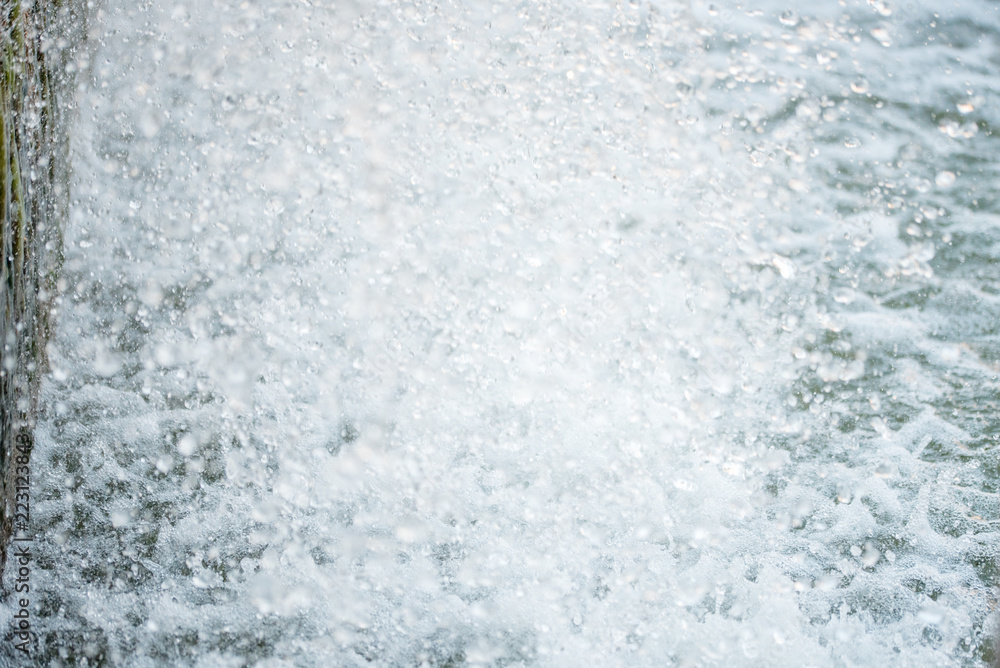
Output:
(0, 0), (85, 568)
